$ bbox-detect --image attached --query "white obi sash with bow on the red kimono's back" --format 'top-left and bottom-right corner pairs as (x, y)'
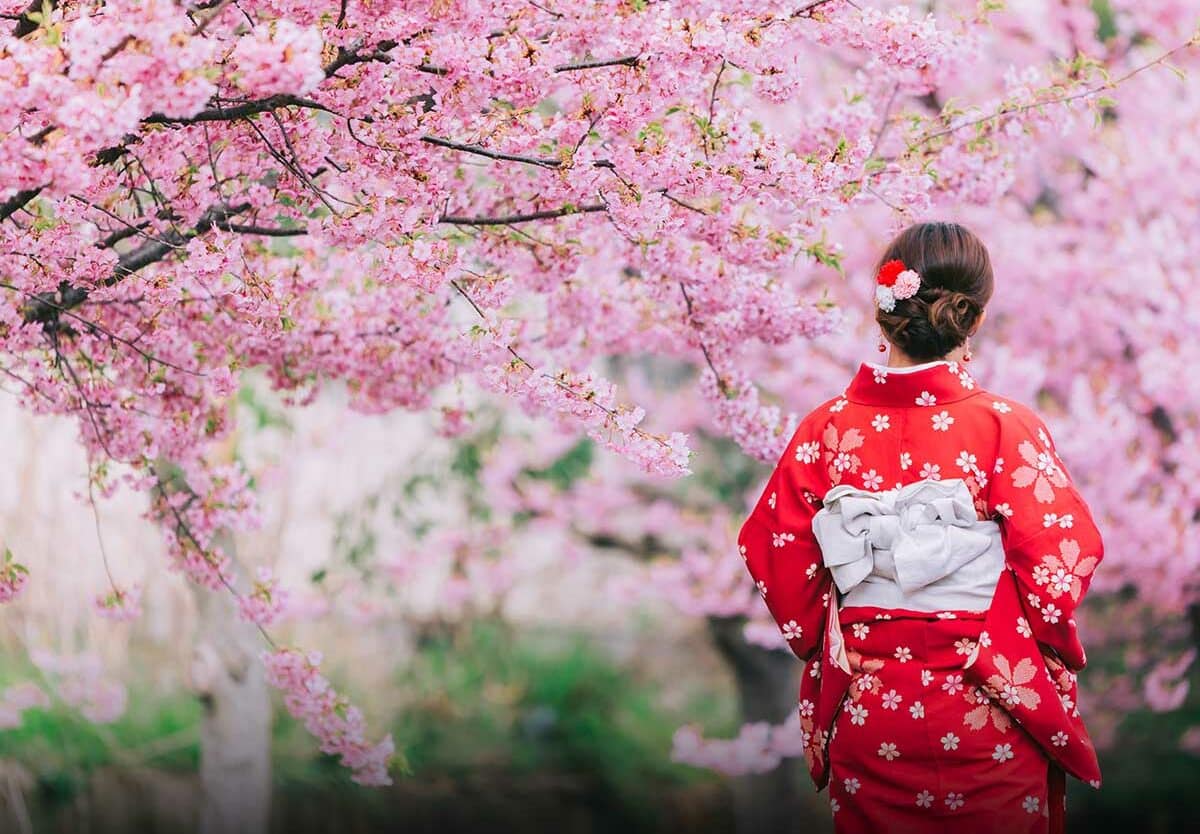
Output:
(812, 478), (1004, 611)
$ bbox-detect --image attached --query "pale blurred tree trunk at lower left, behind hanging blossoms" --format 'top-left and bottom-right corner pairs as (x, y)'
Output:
(192, 538), (271, 834)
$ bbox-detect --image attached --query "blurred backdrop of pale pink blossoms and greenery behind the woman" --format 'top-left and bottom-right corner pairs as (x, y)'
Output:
(0, 0), (1200, 834)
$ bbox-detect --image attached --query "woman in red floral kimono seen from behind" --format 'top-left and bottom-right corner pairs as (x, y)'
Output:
(738, 223), (1103, 834)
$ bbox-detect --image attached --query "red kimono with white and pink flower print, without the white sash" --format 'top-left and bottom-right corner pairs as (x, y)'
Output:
(738, 361), (1103, 834)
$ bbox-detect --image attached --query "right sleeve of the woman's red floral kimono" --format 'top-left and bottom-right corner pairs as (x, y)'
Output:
(989, 407), (1104, 671)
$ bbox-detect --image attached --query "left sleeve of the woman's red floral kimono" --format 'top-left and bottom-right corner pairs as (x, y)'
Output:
(738, 424), (832, 660)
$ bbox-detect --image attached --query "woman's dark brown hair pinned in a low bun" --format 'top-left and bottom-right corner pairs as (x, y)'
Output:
(875, 223), (994, 361)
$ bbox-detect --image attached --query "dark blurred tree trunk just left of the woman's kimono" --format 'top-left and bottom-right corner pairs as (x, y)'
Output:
(708, 617), (820, 834)
